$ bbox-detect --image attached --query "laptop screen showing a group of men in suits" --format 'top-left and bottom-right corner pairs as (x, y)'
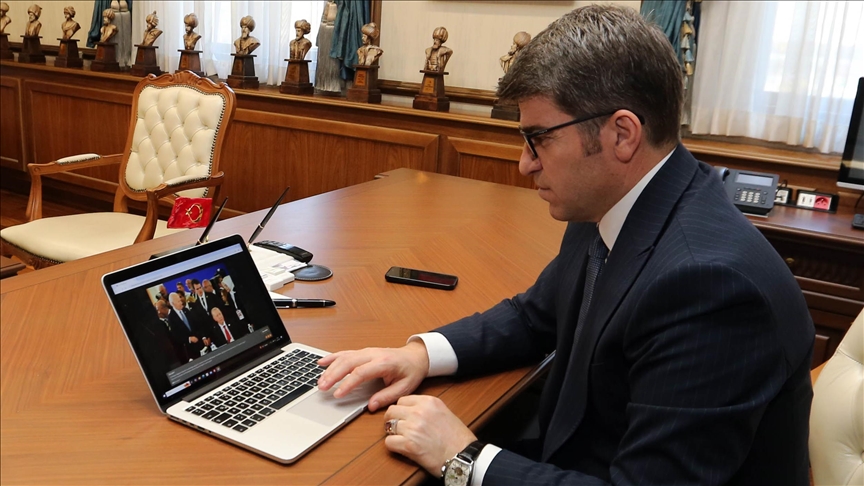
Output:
(102, 235), (291, 411)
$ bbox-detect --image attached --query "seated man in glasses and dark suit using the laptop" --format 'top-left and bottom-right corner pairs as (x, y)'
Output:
(319, 5), (814, 486)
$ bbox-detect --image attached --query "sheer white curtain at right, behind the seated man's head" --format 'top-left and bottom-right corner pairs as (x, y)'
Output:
(690, 1), (864, 153)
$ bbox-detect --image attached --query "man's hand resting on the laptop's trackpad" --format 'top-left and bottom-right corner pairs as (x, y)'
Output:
(318, 341), (429, 412)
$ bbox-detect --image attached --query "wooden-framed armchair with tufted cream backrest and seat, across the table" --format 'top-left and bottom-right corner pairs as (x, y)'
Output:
(0, 71), (235, 268)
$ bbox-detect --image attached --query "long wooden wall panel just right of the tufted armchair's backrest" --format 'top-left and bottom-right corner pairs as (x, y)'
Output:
(221, 109), (439, 212)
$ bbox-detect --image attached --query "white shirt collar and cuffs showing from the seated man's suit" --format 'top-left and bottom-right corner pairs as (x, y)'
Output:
(408, 149), (675, 486)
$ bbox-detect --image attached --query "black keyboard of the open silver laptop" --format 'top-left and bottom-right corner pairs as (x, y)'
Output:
(186, 349), (324, 432)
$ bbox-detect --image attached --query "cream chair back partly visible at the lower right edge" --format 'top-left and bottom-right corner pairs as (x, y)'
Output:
(810, 311), (864, 486)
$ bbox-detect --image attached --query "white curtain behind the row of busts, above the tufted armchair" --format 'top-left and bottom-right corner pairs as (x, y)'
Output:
(132, 0), (325, 85)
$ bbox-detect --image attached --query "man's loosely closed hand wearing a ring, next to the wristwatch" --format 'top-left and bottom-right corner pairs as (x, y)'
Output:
(384, 395), (477, 478)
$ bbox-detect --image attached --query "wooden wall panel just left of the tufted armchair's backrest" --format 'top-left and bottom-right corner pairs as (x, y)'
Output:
(24, 81), (132, 187)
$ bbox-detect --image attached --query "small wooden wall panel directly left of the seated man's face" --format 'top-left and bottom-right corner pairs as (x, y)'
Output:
(441, 137), (536, 189)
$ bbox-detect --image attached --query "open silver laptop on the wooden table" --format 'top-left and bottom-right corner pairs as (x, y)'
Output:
(102, 235), (383, 464)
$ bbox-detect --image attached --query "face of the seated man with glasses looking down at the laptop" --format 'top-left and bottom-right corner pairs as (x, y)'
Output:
(519, 96), (620, 222)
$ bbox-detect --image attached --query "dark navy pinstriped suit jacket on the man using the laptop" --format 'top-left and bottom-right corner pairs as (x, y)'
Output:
(438, 145), (814, 485)
